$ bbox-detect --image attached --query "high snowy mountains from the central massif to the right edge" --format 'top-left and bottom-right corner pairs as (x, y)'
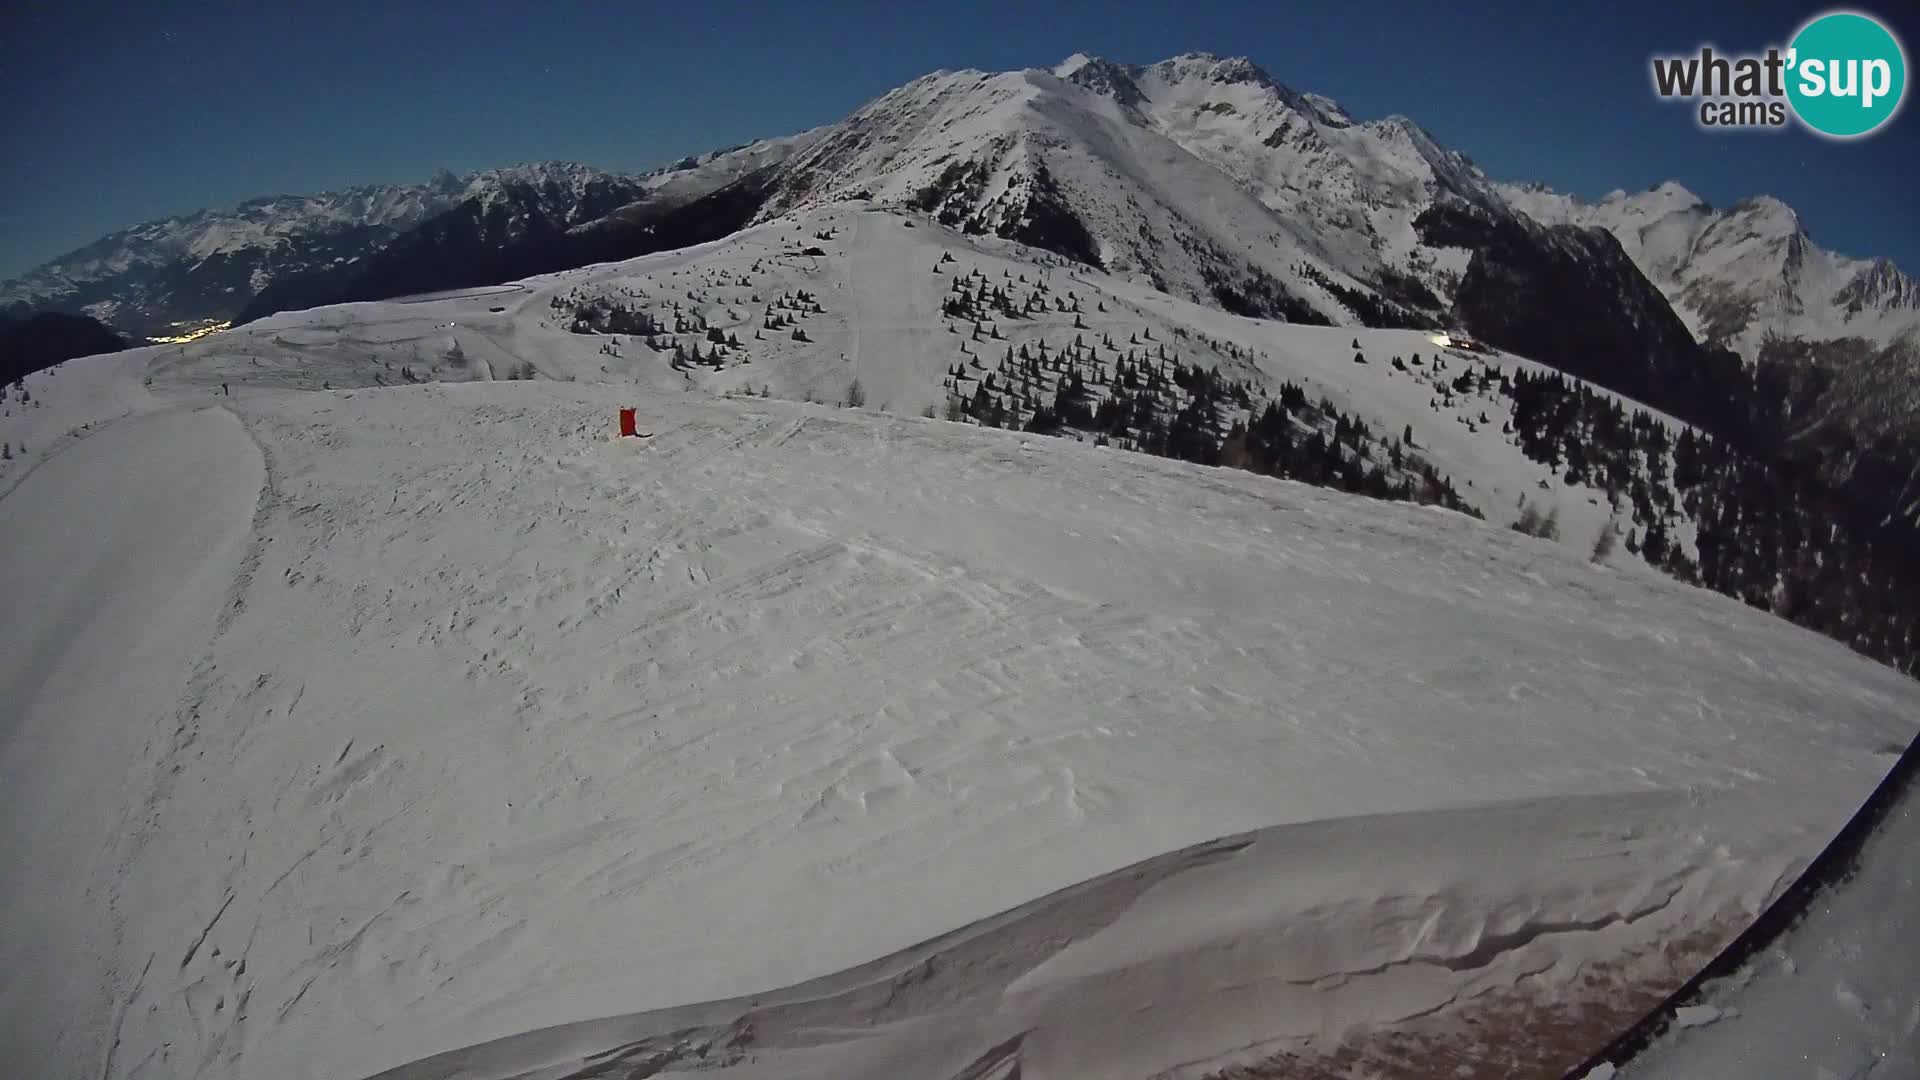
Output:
(733, 54), (1920, 413)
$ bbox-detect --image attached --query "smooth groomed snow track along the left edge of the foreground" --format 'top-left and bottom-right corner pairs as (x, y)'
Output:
(0, 409), (263, 1076)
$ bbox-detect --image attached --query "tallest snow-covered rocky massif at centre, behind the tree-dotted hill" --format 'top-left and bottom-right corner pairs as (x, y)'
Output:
(760, 54), (1503, 325)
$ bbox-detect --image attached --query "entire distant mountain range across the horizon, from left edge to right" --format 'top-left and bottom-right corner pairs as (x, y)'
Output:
(0, 54), (1920, 470)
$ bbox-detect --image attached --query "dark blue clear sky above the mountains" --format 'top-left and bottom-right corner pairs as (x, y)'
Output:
(0, 0), (1920, 277)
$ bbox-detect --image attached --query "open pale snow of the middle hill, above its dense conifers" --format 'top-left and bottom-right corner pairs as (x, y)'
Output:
(97, 204), (1682, 552)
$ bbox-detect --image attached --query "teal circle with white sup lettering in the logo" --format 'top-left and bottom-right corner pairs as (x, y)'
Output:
(1788, 12), (1907, 138)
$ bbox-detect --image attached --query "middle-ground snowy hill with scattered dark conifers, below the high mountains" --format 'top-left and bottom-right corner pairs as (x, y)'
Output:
(33, 197), (1920, 671)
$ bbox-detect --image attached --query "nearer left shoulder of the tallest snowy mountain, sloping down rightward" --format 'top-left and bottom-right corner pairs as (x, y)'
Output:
(764, 61), (1451, 321)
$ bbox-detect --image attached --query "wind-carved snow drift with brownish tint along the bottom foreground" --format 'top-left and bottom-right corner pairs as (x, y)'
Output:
(357, 780), (1827, 1080)
